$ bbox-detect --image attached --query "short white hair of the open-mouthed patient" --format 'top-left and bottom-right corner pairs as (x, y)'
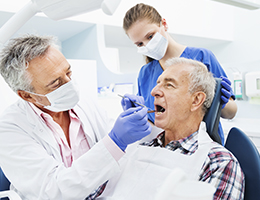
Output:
(166, 58), (216, 114)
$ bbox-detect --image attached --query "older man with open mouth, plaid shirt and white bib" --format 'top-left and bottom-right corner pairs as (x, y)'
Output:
(98, 58), (245, 200)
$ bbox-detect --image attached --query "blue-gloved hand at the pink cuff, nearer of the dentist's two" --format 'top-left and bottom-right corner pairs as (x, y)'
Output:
(108, 106), (152, 151)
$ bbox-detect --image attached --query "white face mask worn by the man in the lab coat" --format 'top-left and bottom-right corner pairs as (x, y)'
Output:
(30, 80), (79, 112)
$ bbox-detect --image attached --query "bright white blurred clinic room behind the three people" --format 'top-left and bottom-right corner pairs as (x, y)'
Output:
(0, 0), (260, 149)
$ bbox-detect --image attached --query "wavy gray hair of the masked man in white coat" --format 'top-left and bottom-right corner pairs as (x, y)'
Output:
(0, 35), (59, 93)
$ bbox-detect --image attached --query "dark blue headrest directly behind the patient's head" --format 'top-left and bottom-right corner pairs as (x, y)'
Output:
(203, 78), (222, 144)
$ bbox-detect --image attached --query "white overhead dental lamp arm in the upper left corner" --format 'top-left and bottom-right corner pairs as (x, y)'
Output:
(0, 0), (121, 44)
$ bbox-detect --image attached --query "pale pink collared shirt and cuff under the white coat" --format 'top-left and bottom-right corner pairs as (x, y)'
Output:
(29, 103), (124, 167)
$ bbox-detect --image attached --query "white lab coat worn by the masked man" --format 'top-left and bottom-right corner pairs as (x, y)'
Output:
(0, 96), (120, 200)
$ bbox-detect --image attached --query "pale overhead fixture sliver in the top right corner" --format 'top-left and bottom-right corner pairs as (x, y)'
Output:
(213, 0), (260, 10)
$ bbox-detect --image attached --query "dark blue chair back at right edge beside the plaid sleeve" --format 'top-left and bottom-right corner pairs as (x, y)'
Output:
(225, 127), (260, 200)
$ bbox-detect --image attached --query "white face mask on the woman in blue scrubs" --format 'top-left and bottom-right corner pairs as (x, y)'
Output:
(137, 32), (168, 60)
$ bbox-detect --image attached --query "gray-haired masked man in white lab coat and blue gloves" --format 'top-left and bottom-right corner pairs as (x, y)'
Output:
(0, 35), (151, 200)
